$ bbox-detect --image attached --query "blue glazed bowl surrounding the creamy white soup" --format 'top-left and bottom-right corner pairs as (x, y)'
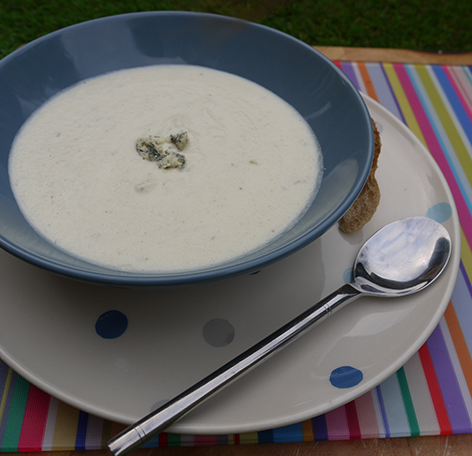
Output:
(0, 12), (374, 287)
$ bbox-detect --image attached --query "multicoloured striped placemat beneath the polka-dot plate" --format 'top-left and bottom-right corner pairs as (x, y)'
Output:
(0, 62), (472, 452)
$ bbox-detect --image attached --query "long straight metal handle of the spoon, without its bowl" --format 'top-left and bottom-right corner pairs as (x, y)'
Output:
(107, 284), (361, 456)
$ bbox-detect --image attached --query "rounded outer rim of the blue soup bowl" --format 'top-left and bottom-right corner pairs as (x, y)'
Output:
(0, 11), (374, 288)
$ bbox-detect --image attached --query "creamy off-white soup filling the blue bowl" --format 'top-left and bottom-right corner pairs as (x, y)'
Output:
(9, 65), (322, 272)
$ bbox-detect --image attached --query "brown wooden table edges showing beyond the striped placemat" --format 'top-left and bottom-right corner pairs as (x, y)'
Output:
(4, 46), (472, 456)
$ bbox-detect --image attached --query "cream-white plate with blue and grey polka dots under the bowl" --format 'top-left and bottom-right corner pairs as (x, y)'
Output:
(0, 93), (460, 434)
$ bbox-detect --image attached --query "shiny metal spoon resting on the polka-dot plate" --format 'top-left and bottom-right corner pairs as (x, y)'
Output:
(107, 217), (451, 456)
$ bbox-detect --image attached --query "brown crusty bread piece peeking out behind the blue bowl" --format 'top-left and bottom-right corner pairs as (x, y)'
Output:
(339, 119), (382, 233)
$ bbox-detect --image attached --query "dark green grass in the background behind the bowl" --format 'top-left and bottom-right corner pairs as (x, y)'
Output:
(0, 0), (472, 58)
